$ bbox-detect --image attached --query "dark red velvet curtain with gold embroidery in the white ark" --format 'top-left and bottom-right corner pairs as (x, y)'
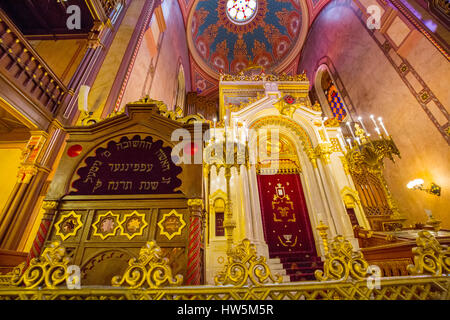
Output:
(258, 174), (316, 256)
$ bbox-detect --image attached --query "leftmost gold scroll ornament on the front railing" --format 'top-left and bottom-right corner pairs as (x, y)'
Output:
(11, 241), (70, 289)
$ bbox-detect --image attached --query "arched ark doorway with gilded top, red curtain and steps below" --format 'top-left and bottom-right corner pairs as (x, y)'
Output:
(257, 135), (320, 281)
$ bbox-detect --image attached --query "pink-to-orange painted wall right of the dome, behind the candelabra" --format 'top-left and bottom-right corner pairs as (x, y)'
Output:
(298, 2), (450, 228)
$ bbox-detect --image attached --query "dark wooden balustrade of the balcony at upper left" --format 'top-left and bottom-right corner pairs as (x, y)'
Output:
(0, 9), (68, 114)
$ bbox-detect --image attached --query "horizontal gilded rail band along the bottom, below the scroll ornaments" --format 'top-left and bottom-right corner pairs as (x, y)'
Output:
(0, 276), (450, 300)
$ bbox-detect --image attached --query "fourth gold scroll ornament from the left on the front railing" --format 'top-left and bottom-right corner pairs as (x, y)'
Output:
(314, 235), (369, 281)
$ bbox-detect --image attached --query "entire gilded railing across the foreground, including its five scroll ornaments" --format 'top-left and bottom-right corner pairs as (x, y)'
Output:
(0, 231), (450, 300)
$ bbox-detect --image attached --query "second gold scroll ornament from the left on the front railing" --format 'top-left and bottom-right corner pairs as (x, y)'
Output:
(111, 241), (183, 289)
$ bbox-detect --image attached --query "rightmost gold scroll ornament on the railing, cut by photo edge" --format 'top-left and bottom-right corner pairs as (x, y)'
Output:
(407, 230), (450, 276)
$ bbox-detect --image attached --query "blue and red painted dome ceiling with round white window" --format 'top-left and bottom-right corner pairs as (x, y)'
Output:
(188, 0), (307, 78)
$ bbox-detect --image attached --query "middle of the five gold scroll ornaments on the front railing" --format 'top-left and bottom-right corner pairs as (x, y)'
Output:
(214, 239), (283, 287)
